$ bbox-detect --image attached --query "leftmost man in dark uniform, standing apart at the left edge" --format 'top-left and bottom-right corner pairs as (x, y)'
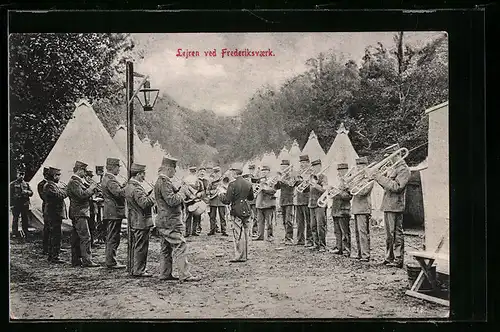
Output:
(10, 167), (33, 238)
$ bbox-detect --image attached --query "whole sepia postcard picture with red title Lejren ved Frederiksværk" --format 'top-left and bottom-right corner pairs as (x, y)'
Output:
(8, 31), (450, 321)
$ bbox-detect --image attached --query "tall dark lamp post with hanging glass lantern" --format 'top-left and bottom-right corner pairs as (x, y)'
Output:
(125, 61), (160, 275)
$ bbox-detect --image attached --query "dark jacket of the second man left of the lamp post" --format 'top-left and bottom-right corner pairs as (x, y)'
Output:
(66, 174), (94, 219)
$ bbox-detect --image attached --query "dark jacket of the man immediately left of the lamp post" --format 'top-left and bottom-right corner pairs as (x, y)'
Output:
(101, 173), (125, 219)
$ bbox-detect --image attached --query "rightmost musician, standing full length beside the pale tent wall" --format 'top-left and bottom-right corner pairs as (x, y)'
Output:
(373, 144), (411, 268)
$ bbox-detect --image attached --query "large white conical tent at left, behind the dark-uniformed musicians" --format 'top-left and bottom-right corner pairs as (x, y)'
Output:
(30, 100), (127, 226)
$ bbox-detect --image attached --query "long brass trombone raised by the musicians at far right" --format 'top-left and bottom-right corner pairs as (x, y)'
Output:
(348, 148), (409, 196)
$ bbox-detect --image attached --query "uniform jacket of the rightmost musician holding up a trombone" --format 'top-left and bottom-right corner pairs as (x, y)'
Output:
(377, 162), (411, 212)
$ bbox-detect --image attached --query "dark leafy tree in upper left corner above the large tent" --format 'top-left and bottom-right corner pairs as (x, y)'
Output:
(9, 33), (134, 178)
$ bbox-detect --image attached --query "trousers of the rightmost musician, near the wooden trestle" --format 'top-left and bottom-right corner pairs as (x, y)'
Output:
(384, 212), (405, 264)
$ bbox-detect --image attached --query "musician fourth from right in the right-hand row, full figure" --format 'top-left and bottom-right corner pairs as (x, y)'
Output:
(309, 159), (328, 252)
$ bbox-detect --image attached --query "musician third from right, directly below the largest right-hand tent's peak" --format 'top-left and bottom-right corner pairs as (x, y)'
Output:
(332, 163), (352, 257)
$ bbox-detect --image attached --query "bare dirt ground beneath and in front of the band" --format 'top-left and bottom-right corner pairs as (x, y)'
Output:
(10, 214), (449, 319)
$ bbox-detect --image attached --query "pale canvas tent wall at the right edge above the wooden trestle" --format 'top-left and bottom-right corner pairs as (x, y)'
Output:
(420, 102), (450, 267)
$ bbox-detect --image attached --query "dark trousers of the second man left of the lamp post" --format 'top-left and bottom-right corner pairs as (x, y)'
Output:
(71, 217), (92, 265)
